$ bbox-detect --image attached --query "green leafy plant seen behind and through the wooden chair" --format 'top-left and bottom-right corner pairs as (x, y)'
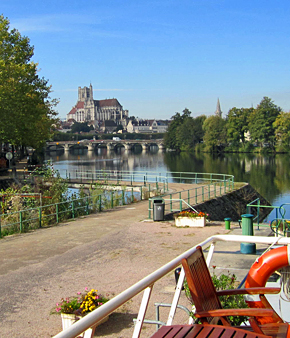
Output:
(184, 267), (248, 326)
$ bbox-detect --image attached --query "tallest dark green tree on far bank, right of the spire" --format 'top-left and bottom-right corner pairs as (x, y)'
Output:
(249, 96), (282, 148)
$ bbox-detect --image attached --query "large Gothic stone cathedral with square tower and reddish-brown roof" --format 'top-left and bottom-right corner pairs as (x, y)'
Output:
(67, 85), (129, 128)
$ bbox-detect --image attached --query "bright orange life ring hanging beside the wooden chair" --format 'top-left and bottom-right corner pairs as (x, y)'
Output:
(245, 246), (290, 324)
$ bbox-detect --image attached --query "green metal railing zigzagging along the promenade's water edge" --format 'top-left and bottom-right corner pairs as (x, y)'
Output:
(0, 167), (234, 237)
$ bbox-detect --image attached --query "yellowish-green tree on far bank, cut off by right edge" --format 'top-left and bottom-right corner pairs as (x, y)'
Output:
(273, 112), (290, 151)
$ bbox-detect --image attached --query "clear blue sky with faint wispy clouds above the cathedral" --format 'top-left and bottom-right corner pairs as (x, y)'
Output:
(0, 0), (290, 119)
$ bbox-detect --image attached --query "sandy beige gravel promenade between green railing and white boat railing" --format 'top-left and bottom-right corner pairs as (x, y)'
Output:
(0, 177), (272, 338)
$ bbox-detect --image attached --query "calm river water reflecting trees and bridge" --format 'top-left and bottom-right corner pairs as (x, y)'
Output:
(46, 147), (290, 220)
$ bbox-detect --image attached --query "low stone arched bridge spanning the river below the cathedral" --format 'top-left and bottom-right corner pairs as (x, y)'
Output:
(46, 140), (165, 152)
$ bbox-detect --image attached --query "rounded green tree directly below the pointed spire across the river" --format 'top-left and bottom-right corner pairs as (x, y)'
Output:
(203, 115), (226, 152)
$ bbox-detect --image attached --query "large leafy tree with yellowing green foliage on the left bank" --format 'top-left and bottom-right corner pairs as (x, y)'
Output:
(0, 15), (57, 148)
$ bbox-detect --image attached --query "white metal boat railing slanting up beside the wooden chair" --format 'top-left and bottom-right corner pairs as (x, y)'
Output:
(54, 235), (290, 338)
